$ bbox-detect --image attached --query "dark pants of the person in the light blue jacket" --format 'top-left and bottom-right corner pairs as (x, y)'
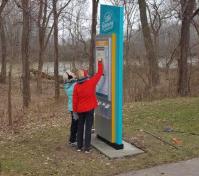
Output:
(69, 111), (78, 143)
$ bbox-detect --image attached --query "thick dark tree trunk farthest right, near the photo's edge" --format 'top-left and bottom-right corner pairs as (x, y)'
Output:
(178, 0), (195, 96)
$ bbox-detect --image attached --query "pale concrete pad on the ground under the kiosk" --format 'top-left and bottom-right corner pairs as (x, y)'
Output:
(91, 134), (144, 159)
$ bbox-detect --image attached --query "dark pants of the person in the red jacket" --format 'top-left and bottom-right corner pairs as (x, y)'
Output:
(77, 110), (94, 150)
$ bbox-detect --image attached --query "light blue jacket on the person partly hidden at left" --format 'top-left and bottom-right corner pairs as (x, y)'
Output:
(64, 80), (76, 111)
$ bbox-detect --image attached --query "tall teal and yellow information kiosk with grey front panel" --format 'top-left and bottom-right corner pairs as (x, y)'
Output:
(95, 5), (124, 149)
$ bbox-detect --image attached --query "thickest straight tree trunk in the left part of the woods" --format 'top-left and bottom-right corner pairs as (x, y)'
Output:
(21, 0), (31, 107)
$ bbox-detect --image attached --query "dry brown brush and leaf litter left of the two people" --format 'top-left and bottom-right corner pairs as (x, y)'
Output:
(0, 77), (67, 133)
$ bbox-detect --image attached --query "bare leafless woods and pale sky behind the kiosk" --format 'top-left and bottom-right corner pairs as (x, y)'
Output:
(0, 0), (199, 107)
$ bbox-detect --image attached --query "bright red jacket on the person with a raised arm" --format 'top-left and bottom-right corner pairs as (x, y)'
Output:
(73, 62), (103, 113)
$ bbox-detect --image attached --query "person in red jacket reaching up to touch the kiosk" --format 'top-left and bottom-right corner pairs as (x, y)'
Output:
(73, 59), (103, 153)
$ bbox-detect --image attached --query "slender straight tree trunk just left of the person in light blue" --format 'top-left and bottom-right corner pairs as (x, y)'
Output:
(53, 0), (60, 100)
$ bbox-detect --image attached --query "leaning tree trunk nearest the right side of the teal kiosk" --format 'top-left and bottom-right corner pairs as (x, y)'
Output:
(138, 0), (160, 87)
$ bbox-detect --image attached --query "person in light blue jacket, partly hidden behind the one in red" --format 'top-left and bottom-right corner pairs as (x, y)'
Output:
(63, 71), (78, 146)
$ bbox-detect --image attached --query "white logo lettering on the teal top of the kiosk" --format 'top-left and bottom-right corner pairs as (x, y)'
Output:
(102, 12), (114, 32)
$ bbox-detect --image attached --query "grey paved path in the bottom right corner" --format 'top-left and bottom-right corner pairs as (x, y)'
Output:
(118, 158), (199, 176)
